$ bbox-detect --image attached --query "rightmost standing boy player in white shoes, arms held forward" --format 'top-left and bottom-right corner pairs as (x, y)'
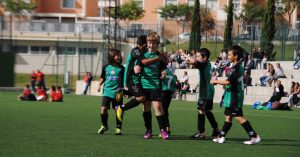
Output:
(211, 45), (261, 145)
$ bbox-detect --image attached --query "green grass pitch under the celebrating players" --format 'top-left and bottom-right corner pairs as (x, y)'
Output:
(0, 92), (300, 157)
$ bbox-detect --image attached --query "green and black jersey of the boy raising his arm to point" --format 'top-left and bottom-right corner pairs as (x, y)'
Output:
(196, 61), (215, 100)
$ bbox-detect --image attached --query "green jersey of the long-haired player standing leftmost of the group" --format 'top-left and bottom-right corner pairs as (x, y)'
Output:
(100, 64), (124, 98)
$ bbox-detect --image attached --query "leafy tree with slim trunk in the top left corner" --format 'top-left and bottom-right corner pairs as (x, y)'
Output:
(0, 0), (36, 50)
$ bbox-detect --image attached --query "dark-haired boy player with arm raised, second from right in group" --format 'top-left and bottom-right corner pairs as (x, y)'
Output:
(181, 48), (220, 139)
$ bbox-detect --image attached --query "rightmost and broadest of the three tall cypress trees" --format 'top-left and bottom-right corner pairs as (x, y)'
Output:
(260, 0), (276, 60)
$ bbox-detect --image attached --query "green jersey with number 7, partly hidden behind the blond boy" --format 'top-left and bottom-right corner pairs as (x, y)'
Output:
(162, 69), (176, 93)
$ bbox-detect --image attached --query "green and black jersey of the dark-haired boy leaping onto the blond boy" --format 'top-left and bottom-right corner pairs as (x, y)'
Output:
(124, 47), (145, 86)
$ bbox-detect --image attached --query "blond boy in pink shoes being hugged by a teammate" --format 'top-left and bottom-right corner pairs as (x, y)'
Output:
(141, 32), (169, 140)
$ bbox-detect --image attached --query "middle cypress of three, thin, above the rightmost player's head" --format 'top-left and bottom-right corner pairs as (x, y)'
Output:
(223, 0), (233, 50)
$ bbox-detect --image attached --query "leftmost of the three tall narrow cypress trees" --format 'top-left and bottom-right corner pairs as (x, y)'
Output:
(189, 0), (201, 50)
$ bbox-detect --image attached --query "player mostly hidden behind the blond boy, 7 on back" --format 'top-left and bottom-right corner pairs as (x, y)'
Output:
(162, 69), (177, 135)
